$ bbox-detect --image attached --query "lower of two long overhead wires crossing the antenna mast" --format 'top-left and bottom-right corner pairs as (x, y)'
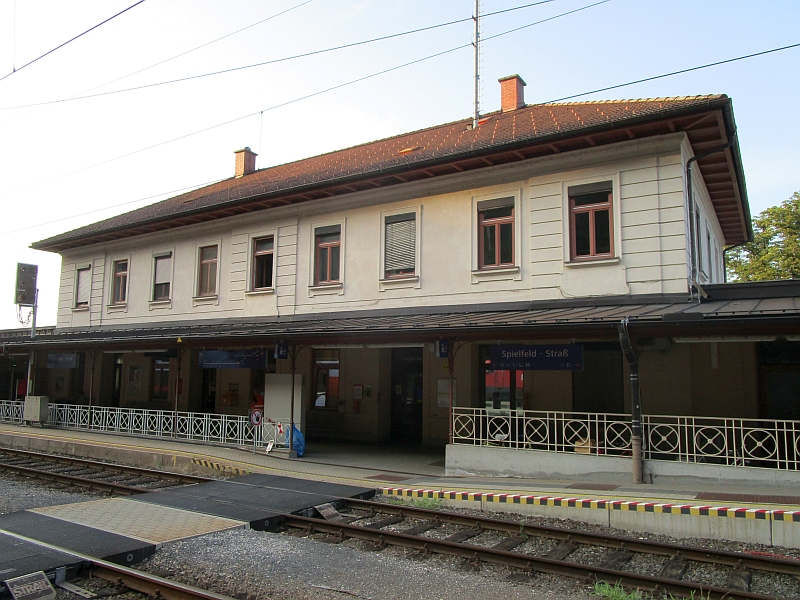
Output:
(1, 0), (611, 202)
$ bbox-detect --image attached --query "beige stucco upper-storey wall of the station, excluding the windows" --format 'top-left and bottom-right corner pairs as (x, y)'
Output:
(50, 134), (724, 328)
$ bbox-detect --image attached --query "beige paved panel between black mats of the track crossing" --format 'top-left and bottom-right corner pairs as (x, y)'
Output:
(31, 498), (247, 544)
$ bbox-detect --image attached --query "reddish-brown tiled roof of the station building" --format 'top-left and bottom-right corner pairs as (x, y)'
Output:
(32, 95), (743, 250)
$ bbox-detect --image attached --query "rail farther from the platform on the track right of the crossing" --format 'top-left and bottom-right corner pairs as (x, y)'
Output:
(283, 515), (774, 600)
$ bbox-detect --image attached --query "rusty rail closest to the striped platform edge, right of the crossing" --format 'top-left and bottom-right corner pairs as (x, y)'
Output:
(345, 498), (800, 575)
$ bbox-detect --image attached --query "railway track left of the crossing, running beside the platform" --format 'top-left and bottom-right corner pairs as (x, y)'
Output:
(0, 448), (213, 495)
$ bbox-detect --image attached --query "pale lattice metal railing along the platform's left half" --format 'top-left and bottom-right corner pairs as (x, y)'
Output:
(0, 400), (289, 447)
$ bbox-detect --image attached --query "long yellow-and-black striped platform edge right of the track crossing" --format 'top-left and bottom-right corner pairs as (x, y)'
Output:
(380, 487), (800, 521)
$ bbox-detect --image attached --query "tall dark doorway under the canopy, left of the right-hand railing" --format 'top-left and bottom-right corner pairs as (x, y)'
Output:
(392, 348), (422, 445)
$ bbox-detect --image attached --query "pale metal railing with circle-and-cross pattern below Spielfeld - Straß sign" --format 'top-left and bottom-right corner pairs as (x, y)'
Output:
(453, 408), (800, 471)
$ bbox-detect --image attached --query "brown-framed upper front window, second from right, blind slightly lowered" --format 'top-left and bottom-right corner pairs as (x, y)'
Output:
(478, 198), (514, 269)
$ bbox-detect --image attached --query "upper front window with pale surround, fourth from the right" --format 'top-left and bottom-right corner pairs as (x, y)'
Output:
(308, 219), (346, 296)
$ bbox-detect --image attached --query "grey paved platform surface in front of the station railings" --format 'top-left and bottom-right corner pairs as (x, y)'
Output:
(0, 423), (800, 511)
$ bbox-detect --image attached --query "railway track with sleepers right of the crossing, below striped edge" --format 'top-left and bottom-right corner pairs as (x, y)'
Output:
(283, 500), (800, 600)
